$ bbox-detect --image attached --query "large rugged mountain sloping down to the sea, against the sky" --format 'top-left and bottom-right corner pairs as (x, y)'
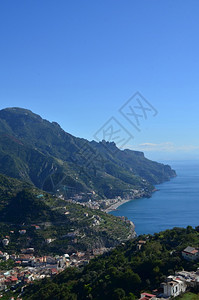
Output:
(0, 108), (176, 199)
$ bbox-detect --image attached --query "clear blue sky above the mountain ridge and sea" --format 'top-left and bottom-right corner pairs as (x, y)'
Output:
(0, 0), (199, 160)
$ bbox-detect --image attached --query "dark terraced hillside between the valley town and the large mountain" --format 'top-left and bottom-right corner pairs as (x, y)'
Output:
(0, 175), (134, 254)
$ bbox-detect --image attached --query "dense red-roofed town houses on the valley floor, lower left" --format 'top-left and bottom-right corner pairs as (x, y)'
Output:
(0, 248), (108, 291)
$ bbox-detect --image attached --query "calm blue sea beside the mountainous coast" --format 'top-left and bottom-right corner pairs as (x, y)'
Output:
(111, 161), (199, 234)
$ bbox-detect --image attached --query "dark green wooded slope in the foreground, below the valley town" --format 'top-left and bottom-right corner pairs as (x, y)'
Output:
(24, 226), (199, 300)
